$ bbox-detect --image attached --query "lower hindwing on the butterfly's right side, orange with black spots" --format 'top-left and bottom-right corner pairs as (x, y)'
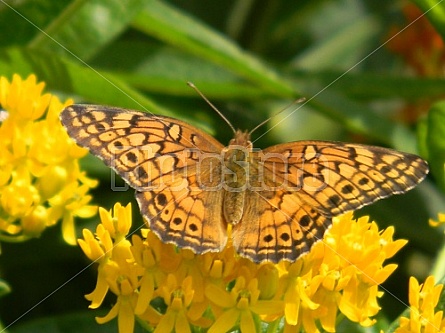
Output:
(232, 190), (331, 262)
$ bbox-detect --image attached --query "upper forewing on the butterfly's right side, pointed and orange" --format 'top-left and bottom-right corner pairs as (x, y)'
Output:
(264, 141), (428, 216)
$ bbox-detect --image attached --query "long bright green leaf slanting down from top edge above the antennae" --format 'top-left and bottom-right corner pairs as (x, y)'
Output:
(128, 0), (295, 98)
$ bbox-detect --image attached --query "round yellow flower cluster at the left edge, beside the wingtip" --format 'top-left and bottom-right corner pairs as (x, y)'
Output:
(0, 75), (97, 244)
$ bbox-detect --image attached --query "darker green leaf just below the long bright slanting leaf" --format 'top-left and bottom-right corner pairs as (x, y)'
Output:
(91, 41), (271, 100)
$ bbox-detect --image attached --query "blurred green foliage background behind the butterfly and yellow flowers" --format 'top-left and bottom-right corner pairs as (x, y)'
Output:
(0, 0), (445, 332)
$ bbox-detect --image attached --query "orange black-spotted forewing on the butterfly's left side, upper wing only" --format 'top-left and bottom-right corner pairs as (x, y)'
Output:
(61, 105), (223, 191)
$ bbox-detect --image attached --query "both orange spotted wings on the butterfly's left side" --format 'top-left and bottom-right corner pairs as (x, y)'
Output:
(61, 105), (227, 253)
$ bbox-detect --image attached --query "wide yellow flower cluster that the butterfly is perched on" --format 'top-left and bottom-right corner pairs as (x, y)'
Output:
(79, 204), (406, 333)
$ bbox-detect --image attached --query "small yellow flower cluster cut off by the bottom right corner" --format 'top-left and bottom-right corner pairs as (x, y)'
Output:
(395, 276), (445, 333)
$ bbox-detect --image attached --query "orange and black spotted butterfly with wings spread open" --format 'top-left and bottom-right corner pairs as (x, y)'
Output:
(60, 104), (428, 263)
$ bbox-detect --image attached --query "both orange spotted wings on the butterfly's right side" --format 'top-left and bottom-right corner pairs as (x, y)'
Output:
(232, 141), (428, 262)
